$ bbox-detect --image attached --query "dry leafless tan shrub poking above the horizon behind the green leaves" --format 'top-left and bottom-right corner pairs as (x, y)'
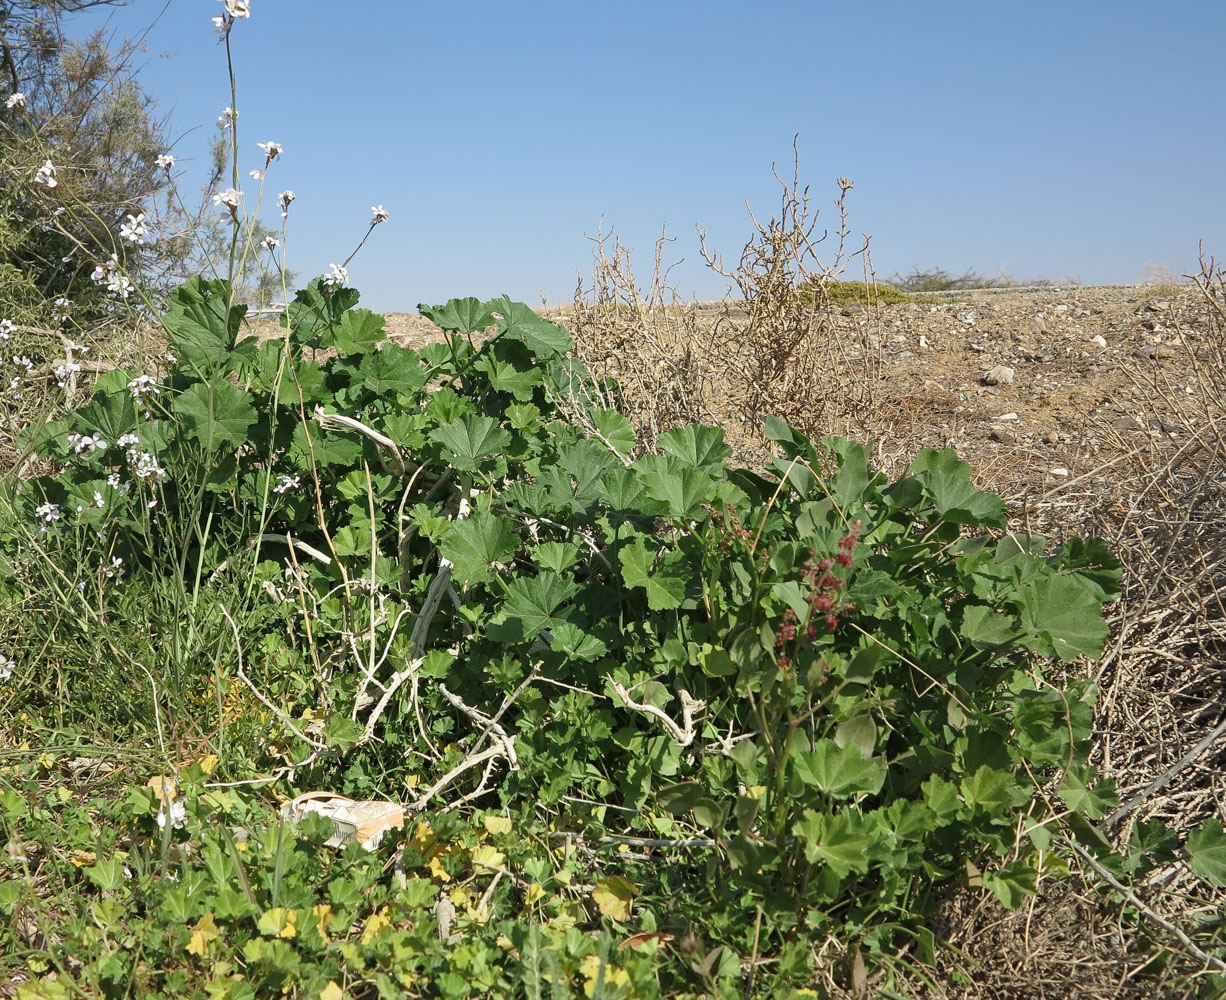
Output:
(563, 141), (878, 461)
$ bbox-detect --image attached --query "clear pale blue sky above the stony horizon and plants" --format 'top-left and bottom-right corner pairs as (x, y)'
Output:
(67, 0), (1226, 311)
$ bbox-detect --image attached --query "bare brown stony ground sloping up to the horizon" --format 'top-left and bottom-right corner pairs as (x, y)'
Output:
(386, 286), (1209, 490)
